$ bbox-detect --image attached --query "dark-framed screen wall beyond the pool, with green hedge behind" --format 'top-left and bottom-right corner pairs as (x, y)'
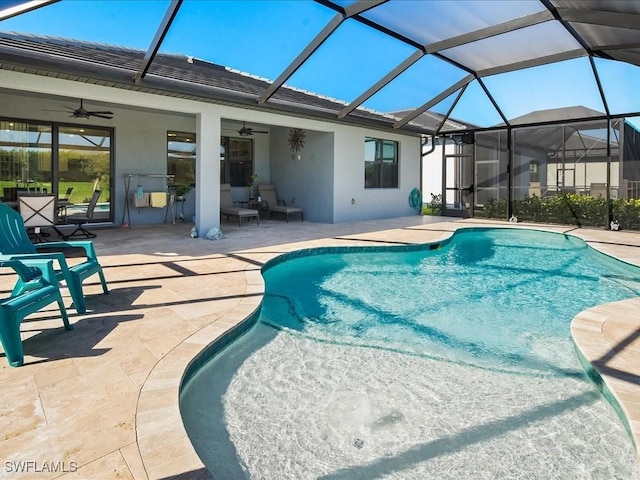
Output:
(436, 119), (640, 229)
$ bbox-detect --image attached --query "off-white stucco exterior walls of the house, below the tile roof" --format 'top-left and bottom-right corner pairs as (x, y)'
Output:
(0, 70), (420, 232)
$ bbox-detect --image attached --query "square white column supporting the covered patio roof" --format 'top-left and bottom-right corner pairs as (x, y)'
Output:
(195, 111), (221, 236)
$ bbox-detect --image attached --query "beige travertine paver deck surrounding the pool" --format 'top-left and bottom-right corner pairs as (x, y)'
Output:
(0, 216), (640, 479)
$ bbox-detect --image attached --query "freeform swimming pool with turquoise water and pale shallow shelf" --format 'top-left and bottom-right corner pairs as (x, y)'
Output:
(181, 229), (640, 479)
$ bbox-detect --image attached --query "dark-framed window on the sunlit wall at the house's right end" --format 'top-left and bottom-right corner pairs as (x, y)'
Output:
(364, 137), (398, 188)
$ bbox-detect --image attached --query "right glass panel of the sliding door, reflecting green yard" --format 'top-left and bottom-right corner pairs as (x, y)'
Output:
(57, 126), (112, 222)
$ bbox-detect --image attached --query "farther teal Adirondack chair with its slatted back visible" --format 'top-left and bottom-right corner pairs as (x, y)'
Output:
(0, 204), (109, 313)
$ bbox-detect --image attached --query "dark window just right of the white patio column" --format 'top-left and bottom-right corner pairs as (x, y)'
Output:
(220, 137), (253, 187)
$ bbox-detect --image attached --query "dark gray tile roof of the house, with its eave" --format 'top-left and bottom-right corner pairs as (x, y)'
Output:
(0, 31), (424, 133)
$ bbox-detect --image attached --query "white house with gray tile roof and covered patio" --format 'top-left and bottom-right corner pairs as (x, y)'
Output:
(0, 32), (421, 231)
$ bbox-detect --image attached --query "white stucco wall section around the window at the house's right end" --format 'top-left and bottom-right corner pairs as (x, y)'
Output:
(271, 125), (420, 223)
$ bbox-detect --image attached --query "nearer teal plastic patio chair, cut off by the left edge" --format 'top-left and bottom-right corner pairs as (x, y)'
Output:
(0, 260), (73, 367)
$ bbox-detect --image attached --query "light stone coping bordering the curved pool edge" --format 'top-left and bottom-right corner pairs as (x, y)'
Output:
(135, 222), (640, 479)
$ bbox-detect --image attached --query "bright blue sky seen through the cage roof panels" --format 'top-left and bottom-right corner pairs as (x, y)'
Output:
(0, 0), (640, 126)
